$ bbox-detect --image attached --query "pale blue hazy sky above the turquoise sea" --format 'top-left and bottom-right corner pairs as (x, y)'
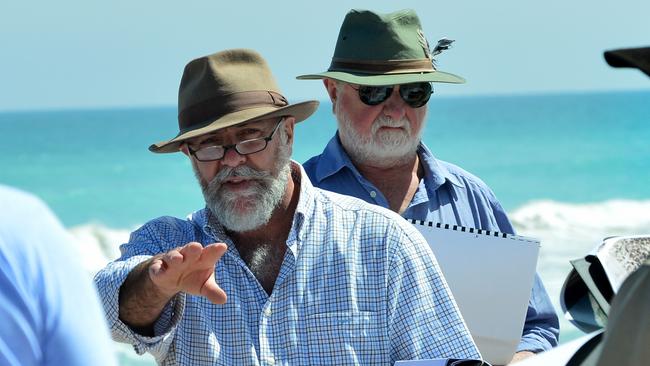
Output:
(0, 0), (650, 111)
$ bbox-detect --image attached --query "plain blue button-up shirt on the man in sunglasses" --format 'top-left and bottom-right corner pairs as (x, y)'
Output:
(304, 133), (560, 352)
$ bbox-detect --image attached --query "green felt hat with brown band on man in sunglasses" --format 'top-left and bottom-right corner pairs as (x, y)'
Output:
(297, 9), (465, 85)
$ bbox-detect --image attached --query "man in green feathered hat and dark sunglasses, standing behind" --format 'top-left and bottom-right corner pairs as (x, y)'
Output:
(298, 10), (559, 364)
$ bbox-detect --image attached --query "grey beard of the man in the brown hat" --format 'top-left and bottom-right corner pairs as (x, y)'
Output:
(194, 145), (291, 232)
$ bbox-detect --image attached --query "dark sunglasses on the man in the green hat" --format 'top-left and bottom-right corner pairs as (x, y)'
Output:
(352, 82), (433, 108)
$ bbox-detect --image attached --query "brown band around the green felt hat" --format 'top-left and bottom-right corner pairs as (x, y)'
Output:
(328, 58), (436, 74)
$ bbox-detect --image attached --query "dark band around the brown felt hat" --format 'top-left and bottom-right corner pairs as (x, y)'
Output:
(178, 90), (289, 134)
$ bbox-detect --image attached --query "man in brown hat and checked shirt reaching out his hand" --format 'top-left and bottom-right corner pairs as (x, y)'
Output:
(95, 50), (479, 366)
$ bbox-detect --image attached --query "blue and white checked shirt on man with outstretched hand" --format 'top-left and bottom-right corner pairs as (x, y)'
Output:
(95, 163), (479, 366)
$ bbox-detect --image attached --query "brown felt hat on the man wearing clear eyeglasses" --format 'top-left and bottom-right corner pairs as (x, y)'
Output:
(149, 49), (318, 153)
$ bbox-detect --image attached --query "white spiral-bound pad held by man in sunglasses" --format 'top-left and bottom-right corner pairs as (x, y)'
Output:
(411, 221), (539, 365)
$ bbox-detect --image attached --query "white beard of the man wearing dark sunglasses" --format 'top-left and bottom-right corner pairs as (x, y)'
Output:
(335, 105), (422, 167)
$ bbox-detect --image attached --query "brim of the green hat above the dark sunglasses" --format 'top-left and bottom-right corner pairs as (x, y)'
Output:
(296, 71), (465, 86)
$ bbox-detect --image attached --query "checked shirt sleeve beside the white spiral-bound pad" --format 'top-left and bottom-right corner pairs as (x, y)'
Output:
(386, 220), (480, 362)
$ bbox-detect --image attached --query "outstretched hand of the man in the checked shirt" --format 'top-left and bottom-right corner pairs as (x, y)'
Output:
(149, 242), (228, 304)
